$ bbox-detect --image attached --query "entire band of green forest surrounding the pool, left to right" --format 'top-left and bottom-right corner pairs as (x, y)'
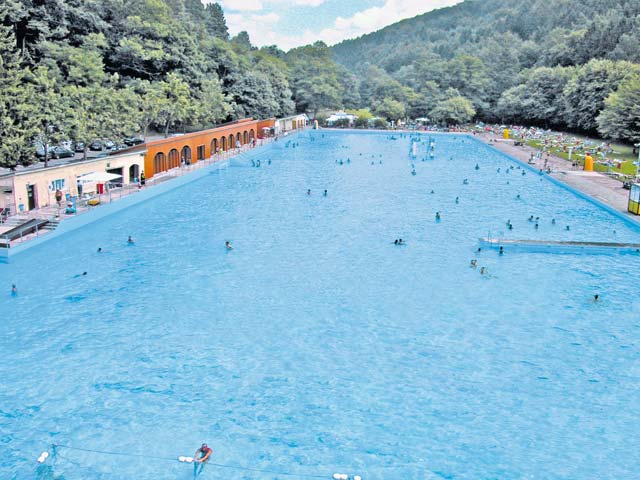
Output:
(0, 0), (640, 171)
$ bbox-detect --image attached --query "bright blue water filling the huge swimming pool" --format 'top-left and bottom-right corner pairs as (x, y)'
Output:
(0, 132), (640, 480)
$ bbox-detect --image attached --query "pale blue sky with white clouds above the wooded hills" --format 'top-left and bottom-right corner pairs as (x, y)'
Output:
(209, 0), (461, 50)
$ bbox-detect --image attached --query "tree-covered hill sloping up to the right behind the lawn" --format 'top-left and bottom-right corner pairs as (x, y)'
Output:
(331, 0), (640, 141)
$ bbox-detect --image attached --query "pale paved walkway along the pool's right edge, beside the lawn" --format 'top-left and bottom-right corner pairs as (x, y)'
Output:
(476, 133), (639, 220)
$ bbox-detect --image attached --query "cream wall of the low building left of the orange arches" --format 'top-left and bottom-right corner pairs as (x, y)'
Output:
(6, 152), (144, 213)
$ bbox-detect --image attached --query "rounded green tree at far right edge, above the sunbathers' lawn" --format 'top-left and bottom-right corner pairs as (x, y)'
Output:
(598, 75), (640, 143)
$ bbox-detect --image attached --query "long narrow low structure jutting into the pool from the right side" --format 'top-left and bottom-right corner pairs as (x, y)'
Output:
(480, 237), (640, 254)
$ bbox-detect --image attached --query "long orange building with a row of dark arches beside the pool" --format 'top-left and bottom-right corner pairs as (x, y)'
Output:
(138, 118), (275, 178)
